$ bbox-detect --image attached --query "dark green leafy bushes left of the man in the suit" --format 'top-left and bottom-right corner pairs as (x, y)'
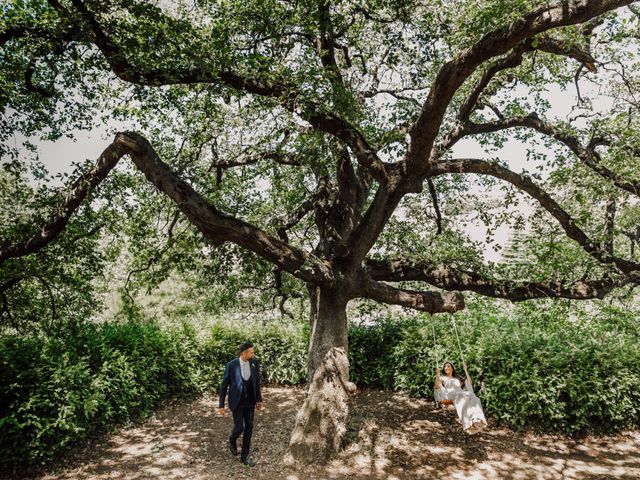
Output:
(0, 322), (208, 468)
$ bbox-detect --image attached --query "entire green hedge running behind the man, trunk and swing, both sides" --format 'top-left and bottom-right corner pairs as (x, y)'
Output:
(0, 302), (640, 469)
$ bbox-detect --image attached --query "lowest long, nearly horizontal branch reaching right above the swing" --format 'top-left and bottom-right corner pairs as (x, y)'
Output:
(366, 259), (640, 302)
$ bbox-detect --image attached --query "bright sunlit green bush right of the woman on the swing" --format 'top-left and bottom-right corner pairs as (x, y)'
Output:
(471, 310), (640, 433)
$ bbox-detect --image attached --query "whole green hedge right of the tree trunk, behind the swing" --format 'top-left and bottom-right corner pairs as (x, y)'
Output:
(349, 303), (640, 434)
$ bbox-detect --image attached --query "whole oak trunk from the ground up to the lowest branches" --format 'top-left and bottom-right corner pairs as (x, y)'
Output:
(285, 287), (356, 464)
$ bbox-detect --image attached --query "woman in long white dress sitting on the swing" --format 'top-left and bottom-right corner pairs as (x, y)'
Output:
(433, 362), (487, 434)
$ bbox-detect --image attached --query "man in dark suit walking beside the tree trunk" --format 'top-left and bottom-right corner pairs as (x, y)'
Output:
(218, 342), (262, 466)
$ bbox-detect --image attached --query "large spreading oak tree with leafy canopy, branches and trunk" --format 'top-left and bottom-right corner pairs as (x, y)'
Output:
(0, 0), (640, 461)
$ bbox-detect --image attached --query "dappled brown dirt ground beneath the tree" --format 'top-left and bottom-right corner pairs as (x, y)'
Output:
(10, 388), (640, 480)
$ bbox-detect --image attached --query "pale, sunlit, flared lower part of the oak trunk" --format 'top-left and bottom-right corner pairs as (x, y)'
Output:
(285, 347), (356, 465)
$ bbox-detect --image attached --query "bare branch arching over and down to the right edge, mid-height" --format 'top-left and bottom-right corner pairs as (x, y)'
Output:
(428, 159), (640, 273)
